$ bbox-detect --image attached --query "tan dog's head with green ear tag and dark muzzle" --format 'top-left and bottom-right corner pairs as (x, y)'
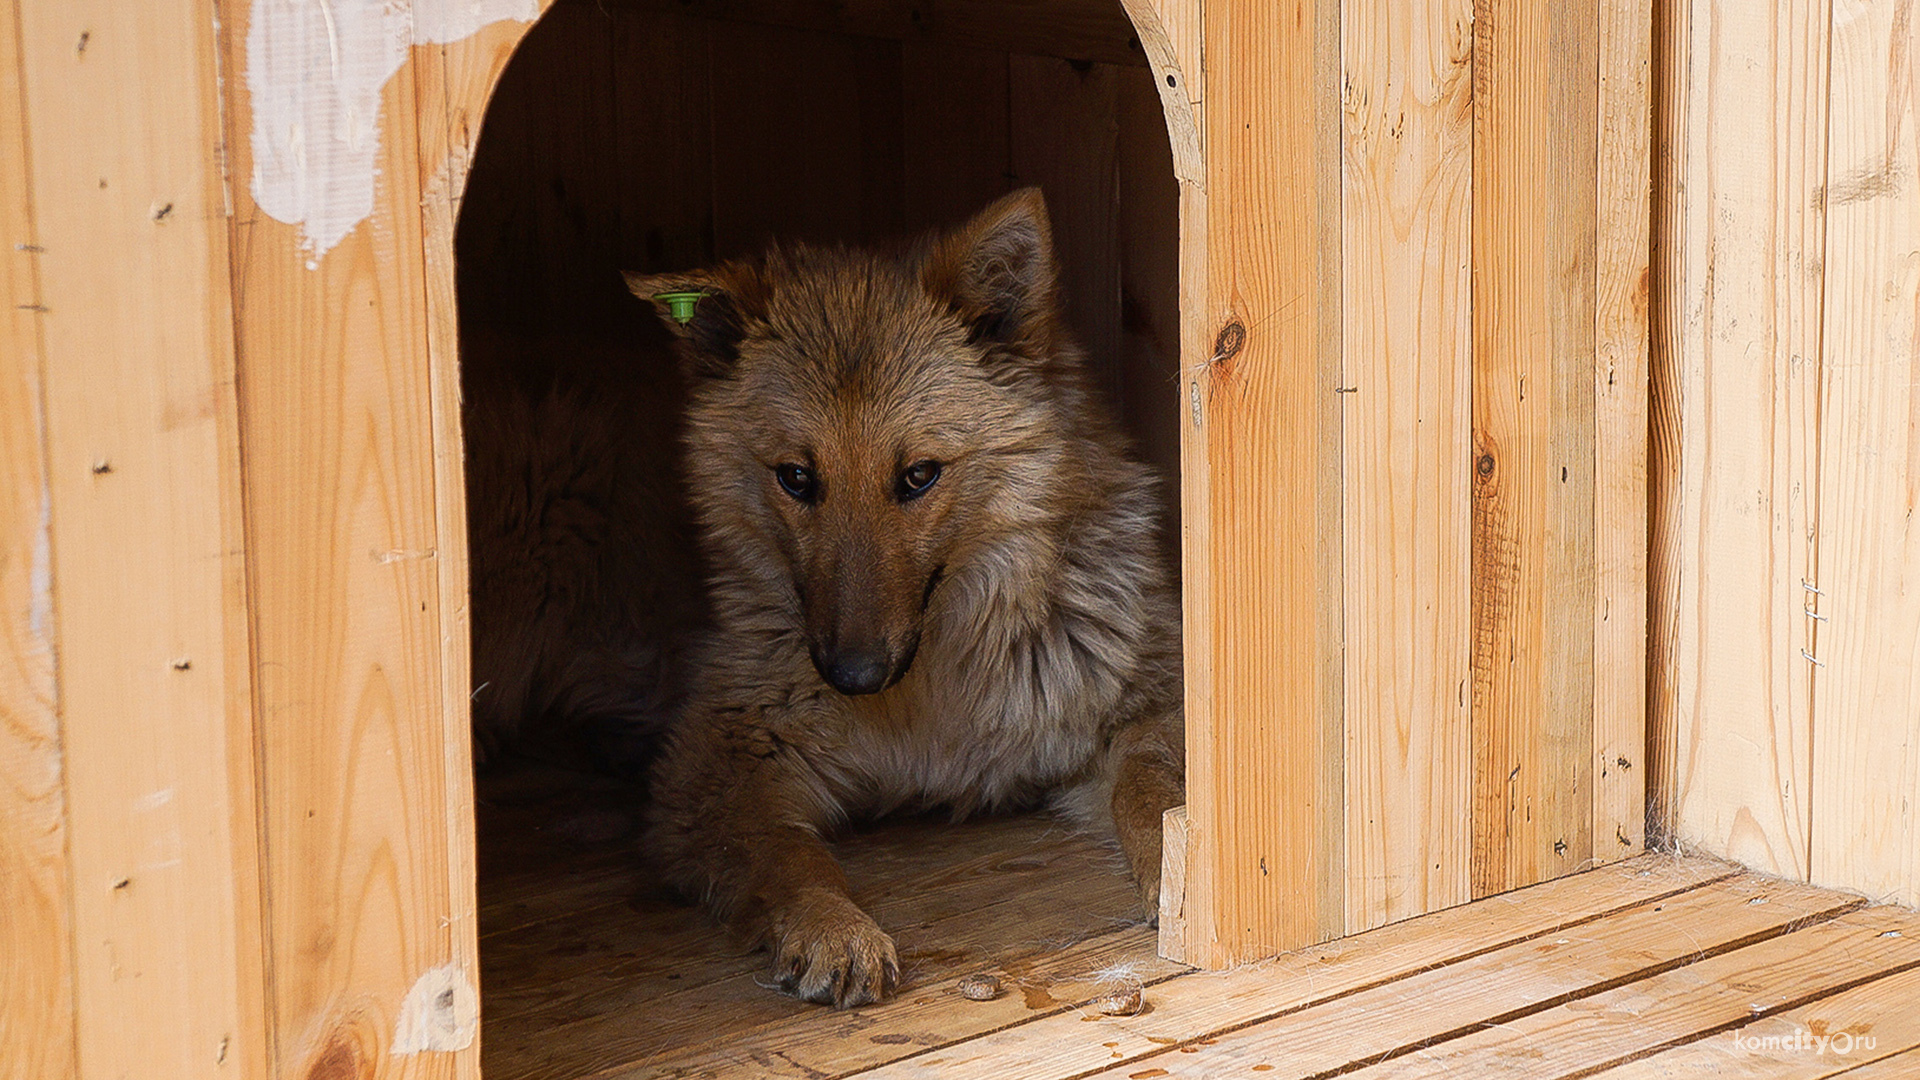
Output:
(628, 188), (1087, 694)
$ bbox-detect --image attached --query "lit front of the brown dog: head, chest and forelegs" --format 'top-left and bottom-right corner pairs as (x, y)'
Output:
(628, 190), (1185, 1007)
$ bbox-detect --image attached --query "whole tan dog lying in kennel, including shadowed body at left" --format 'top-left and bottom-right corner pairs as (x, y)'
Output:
(463, 188), (1185, 1009)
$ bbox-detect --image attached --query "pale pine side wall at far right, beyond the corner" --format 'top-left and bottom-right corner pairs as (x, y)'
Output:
(1653, 0), (1920, 903)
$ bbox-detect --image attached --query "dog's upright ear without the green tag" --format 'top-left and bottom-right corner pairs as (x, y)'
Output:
(920, 188), (1060, 342)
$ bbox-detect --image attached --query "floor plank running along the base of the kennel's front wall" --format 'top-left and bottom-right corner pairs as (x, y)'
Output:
(856, 857), (1732, 1078)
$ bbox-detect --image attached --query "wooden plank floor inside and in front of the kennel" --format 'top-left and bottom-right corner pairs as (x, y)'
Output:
(480, 757), (1920, 1080)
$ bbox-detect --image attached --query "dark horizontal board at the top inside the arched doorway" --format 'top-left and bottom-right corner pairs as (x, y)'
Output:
(603, 0), (1146, 65)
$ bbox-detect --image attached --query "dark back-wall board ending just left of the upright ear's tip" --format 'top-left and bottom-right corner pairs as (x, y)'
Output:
(900, 40), (1012, 231)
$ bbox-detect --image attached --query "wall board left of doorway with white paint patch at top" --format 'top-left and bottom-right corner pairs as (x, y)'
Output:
(221, 0), (478, 1078)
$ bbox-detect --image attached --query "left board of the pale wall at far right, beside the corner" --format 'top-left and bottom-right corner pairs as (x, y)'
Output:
(1655, 0), (1828, 878)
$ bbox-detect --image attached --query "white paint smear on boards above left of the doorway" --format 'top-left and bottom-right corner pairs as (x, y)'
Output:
(246, 0), (540, 269)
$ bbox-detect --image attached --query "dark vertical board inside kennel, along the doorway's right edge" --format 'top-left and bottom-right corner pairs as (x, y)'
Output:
(1116, 67), (1185, 534)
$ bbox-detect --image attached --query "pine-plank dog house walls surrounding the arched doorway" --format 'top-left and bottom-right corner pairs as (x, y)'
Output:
(0, 0), (1920, 1080)
